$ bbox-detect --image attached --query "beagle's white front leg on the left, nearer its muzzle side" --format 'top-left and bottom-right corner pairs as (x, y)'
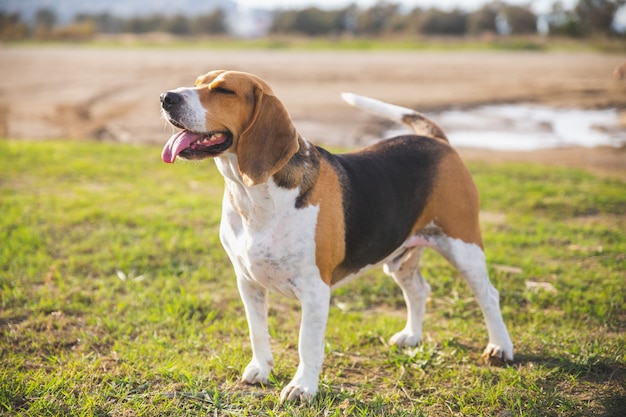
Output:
(237, 277), (274, 384)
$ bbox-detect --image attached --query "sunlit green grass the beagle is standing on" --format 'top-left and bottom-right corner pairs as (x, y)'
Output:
(0, 141), (626, 417)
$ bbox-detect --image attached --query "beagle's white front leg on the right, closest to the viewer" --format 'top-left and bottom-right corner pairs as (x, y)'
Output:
(280, 277), (330, 403)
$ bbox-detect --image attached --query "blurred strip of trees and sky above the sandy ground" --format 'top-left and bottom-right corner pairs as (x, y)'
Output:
(0, 0), (626, 39)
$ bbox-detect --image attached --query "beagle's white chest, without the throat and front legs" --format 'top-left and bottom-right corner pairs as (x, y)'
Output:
(220, 177), (319, 294)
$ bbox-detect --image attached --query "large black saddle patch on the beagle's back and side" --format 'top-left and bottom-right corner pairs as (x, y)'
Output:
(326, 135), (453, 273)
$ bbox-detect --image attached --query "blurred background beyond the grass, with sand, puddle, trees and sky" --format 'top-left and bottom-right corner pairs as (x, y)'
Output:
(0, 0), (626, 171)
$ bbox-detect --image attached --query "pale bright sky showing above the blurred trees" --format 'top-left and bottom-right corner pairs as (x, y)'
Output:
(237, 0), (577, 13)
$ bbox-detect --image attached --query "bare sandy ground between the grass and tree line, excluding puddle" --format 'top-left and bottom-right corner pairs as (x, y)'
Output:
(0, 46), (626, 178)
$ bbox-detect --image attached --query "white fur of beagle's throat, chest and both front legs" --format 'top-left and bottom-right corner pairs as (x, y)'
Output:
(216, 154), (330, 401)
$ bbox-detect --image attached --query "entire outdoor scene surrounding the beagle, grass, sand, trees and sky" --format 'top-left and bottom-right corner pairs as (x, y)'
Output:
(0, 6), (626, 417)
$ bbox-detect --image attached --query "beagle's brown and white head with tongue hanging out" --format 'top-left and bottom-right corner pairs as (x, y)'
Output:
(161, 71), (298, 185)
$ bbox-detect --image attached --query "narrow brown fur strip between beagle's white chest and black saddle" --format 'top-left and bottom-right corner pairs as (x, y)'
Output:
(308, 159), (346, 285)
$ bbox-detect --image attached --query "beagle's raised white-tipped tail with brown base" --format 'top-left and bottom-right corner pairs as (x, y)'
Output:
(341, 93), (448, 142)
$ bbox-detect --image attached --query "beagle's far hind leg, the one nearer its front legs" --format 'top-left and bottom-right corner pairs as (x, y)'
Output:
(384, 247), (430, 346)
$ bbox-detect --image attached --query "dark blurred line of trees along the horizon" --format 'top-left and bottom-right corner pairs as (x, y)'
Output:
(0, 0), (625, 40)
